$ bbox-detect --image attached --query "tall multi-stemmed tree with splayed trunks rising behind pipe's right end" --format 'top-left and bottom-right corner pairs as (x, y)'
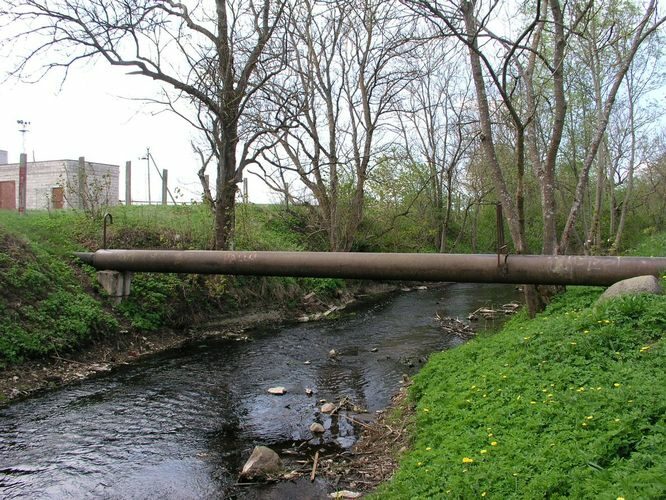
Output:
(407, 0), (664, 312)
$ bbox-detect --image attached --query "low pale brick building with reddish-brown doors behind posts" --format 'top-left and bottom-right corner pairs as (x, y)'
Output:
(0, 152), (120, 210)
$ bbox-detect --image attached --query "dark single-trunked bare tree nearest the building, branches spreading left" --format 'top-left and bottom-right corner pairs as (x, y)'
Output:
(0, 0), (287, 249)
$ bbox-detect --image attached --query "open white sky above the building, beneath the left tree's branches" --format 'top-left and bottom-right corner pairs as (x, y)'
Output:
(0, 60), (275, 203)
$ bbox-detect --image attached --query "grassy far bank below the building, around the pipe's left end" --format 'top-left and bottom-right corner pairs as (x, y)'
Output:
(0, 205), (345, 367)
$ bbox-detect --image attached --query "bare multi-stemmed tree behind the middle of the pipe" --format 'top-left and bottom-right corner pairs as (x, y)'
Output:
(254, 0), (412, 251)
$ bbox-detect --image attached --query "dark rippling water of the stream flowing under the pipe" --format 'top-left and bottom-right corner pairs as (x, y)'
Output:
(0, 284), (519, 500)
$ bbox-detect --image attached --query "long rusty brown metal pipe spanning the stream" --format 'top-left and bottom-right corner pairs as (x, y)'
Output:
(72, 250), (666, 285)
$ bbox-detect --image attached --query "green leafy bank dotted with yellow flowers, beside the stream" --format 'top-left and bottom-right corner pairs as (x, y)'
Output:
(376, 286), (666, 500)
